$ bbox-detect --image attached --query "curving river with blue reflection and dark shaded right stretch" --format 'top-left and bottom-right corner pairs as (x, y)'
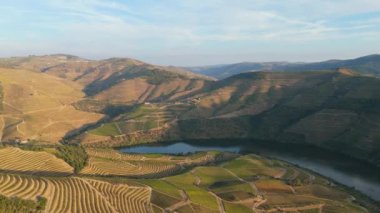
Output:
(120, 140), (380, 201)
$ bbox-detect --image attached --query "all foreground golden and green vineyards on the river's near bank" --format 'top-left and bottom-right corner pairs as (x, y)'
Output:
(0, 147), (377, 213)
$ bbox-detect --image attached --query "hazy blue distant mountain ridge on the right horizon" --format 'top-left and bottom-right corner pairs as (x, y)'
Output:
(186, 55), (380, 79)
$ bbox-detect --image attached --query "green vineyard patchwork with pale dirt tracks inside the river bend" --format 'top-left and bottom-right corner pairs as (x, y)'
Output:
(139, 155), (377, 213)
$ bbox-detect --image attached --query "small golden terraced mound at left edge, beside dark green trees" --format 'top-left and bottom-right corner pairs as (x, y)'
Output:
(0, 147), (73, 175)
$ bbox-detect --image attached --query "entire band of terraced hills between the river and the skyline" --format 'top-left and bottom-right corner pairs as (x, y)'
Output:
(0, 55), (380, 164)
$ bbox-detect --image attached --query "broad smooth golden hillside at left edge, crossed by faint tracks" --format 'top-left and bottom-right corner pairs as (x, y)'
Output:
(0, 69), (101, 142)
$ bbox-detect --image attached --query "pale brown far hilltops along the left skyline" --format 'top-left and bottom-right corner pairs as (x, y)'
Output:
(0, 54), (211, 85)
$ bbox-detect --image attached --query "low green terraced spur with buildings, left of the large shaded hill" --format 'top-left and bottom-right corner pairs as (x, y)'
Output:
(80, 103), (192, 147)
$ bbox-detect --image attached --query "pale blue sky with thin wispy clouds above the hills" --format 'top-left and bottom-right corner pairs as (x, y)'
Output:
(0, 0), (380, 66)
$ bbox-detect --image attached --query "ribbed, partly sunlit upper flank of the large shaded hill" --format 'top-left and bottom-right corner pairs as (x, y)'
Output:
(182, 72), (324, 118)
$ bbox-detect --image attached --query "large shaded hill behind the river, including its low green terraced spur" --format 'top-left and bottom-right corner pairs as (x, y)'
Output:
(78, 69), (380, 165)
